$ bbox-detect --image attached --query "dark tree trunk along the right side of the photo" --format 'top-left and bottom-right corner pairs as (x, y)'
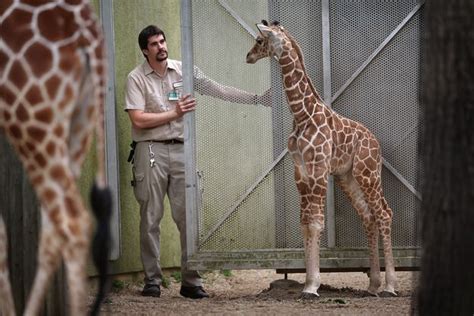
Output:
(415, 0), (474, 316)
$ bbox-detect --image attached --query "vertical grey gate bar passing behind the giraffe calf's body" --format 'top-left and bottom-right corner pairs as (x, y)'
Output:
(321, 0), (336, 248)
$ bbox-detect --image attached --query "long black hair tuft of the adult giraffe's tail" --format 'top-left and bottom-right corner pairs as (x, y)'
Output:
(90, 183), (112, 315)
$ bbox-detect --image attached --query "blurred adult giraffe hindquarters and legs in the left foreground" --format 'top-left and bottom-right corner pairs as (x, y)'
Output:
(0, 0), (106, 315)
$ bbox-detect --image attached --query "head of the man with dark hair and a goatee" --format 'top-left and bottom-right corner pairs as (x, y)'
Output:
(138, 25), (168, 62)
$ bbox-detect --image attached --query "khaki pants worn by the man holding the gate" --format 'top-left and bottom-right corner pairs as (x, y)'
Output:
(133, 142), (201, 286)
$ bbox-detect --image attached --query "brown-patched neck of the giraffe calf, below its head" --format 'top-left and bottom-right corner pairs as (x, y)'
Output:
(279, 48), (324, 124)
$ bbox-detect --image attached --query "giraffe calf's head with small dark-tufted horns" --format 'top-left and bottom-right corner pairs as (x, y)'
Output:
(246, 20), (286, 64)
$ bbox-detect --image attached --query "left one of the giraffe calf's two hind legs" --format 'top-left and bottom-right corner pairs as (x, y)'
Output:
(335, 171), (382, 295)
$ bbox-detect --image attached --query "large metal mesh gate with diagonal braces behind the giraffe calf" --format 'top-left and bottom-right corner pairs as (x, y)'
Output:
(181, 0), (423, 271)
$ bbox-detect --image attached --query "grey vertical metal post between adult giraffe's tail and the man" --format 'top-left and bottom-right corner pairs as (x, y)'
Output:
(100, 0), (121, 260)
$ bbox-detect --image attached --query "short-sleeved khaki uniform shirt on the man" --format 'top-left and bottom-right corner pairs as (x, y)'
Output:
(125, 59), (184, 142)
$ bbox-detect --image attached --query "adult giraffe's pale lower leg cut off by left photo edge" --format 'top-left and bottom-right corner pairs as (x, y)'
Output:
(0, 214), (15, 316)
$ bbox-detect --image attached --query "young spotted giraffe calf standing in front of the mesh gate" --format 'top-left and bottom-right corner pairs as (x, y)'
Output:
(247, 21), (396, 298)
